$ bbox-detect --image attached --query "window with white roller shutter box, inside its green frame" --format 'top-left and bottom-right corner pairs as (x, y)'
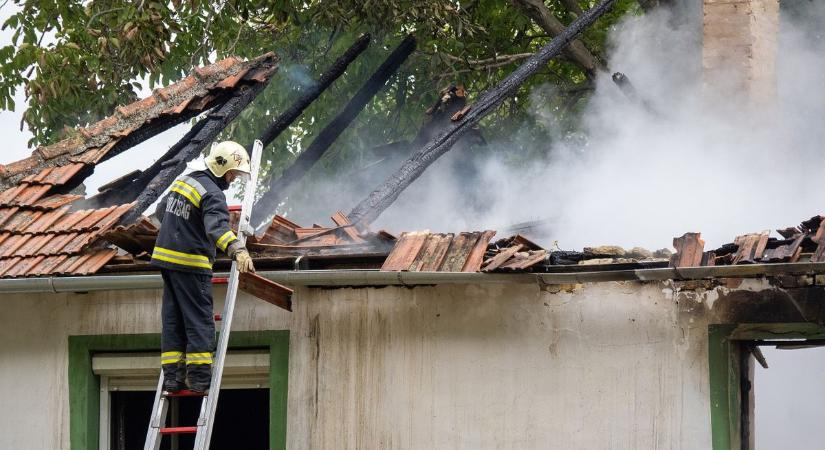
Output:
(92, 350), (269, 450)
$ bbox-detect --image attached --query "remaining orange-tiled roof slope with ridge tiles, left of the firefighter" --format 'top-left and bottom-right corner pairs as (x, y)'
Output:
(0, 53), (277, 277)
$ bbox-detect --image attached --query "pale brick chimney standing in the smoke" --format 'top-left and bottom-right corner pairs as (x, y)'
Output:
(702, 0), (779, 105)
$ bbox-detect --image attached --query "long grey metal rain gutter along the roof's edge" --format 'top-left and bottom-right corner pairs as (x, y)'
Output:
(0, 263), (825, 294)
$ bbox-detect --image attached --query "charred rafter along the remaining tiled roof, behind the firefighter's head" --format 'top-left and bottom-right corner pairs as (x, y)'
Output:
(120, 81), (271, 224)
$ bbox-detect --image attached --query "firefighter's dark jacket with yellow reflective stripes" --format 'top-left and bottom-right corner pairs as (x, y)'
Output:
(152, 171), (238, 274)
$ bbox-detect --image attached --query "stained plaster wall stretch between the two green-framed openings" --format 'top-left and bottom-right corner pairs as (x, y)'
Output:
(287, 283), (711, 450)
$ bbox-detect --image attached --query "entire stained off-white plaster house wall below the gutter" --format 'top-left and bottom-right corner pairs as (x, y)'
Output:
(0, 282), (740, 450)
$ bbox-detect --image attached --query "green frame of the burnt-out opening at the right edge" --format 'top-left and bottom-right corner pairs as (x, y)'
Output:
(708, 323), (825, 450)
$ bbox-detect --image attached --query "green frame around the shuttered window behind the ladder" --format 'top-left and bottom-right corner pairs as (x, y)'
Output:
(68, 330), (289, 450)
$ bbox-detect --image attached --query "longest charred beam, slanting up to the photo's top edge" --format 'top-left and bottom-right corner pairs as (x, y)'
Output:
(347, 0), (616, 227)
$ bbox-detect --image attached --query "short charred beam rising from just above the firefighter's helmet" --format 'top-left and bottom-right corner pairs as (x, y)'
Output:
(247, 34), (370, 154)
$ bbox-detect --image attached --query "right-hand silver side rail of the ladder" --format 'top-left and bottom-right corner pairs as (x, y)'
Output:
(194, 140), (263, 450)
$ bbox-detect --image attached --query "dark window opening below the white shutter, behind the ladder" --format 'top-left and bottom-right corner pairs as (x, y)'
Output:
(109, 389), (269, 450)
